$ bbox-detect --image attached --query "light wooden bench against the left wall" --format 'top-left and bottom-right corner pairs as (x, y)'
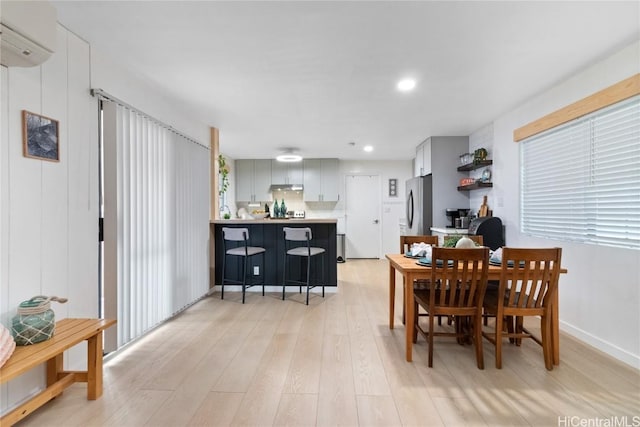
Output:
(0, 319), (116, 426)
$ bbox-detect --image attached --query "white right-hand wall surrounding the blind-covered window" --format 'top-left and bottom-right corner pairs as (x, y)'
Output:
(488, 41), (640, 368)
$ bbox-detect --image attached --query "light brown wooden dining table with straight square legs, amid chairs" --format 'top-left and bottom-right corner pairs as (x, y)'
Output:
(385, 254), (567, 365)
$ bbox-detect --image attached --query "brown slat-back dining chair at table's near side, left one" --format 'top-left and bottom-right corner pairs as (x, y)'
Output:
(413, 246), (489, 369)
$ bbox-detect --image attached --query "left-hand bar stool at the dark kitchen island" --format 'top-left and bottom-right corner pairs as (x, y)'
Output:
(220, 227), (266, 304)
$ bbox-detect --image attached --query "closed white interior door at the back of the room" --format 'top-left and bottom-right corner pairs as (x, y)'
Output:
(345, 175), (381, 259)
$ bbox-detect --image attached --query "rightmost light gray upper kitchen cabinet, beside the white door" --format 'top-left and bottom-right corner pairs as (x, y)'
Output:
(303, 159), (340, 202)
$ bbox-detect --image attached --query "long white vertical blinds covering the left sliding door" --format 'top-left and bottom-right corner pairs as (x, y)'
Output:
(103, 102), (209, 347)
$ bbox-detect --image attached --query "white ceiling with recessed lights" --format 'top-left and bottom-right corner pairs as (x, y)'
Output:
(52, 1), (640, 159)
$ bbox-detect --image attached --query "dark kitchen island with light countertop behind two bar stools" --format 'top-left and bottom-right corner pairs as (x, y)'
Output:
(210, 219), (338, 292)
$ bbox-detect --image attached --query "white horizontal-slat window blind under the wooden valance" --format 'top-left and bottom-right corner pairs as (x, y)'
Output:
(520, 96), (640, 249)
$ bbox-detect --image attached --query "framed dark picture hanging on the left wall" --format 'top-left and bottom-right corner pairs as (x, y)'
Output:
(22, 110), (60, 162)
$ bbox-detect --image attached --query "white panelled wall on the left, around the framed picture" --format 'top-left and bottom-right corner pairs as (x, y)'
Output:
(0, 26), (209, 412)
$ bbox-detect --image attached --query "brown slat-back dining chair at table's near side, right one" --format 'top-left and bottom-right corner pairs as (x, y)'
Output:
(482, 247), (562, 370)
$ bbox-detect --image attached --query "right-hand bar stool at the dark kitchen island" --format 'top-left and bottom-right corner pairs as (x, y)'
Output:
(282, 227), (325, 305)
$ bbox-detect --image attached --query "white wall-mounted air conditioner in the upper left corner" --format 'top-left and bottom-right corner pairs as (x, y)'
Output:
(0, 1), (57, 67)
